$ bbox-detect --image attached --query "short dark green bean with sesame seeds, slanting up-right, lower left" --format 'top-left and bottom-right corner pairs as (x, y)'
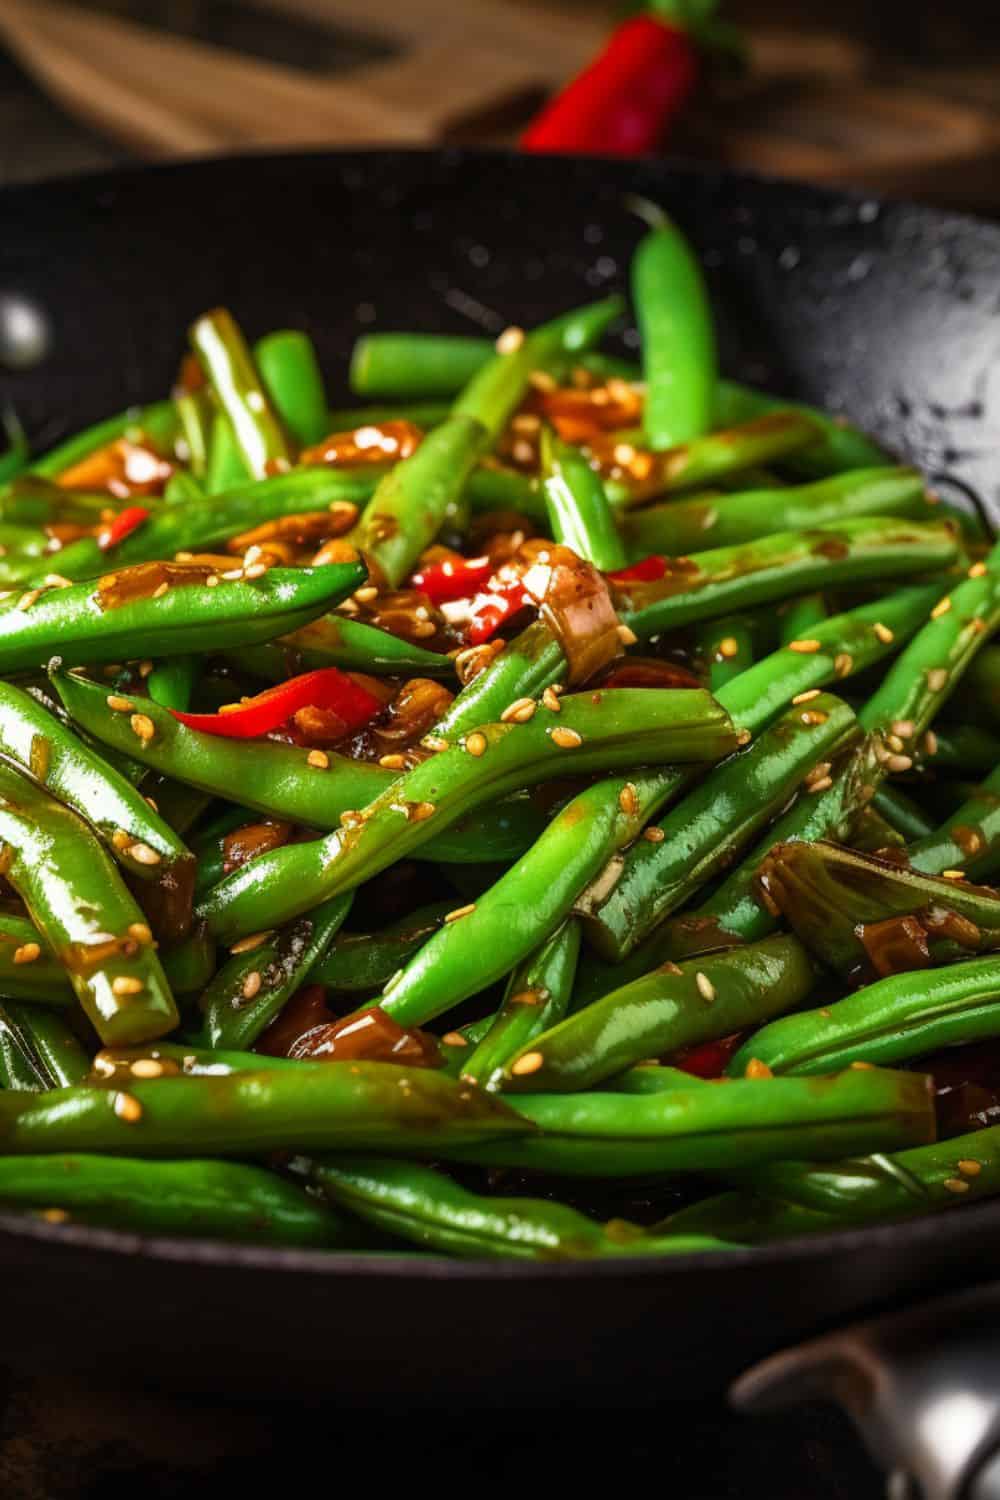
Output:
(201, 893), (352, 1050)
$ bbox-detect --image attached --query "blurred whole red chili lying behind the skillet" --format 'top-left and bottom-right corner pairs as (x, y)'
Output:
(520, 15), (699, 156)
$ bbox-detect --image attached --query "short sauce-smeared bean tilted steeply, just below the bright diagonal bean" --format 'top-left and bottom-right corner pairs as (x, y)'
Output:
(462, 918), (580, 1094)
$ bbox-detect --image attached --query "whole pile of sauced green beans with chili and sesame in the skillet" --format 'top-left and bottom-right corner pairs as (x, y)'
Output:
(0, 206), (1000, 1262)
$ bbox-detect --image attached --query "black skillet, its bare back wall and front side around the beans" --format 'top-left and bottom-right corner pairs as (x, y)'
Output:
(0, 152), (1000, 1428)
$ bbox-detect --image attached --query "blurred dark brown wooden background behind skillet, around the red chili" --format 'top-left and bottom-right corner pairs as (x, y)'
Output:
(0, 0), (1000, 216)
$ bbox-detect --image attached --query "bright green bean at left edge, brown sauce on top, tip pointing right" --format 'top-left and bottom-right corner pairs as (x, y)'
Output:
(0, 563), (366, 674)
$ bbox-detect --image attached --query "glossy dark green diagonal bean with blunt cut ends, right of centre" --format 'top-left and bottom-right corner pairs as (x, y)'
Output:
(587, 695), (861, 959)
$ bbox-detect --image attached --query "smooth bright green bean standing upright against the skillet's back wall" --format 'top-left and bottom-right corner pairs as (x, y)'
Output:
(631, 210), (717, 449)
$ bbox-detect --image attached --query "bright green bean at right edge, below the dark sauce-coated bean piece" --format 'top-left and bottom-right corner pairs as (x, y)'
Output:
(729, 957), (1000, 1080)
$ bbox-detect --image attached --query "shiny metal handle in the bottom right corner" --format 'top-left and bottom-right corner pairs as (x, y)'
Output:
(730, 1284), (1000, 1500)
